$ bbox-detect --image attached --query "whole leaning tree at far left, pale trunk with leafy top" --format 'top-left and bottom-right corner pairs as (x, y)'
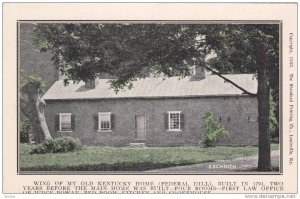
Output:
(20, 76), (52, 143)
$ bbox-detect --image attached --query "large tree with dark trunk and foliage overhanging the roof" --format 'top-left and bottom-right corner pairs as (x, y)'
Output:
(35, 23), (279, 171)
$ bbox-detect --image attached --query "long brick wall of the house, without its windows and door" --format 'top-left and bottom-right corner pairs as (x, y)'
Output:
(45, 96), (258, 146)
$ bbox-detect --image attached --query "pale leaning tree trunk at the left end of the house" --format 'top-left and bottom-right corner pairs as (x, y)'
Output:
(20, 92), (52, 143)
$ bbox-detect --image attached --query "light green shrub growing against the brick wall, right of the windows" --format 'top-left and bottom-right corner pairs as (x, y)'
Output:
(203, 110), (229, 147)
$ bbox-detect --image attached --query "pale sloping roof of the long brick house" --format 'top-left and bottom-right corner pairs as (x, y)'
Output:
(43, 74), (257, 100)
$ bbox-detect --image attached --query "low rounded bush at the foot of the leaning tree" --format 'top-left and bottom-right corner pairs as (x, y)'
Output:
(30, 137), (83, 154)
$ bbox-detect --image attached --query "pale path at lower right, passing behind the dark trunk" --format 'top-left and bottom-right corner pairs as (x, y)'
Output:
(146, 150), (280, 173)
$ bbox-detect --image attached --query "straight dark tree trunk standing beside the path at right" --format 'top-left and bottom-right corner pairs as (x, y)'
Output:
(255, 41), (271, 171)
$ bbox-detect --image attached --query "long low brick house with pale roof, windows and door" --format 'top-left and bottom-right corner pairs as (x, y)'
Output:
(43, 73), (258, 146)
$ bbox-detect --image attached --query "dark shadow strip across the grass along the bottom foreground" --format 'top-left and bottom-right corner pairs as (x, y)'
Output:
(20, 161), (213, 171)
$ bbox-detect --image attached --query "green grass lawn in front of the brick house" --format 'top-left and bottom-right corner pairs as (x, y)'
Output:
(19, 144), (279, 171)
